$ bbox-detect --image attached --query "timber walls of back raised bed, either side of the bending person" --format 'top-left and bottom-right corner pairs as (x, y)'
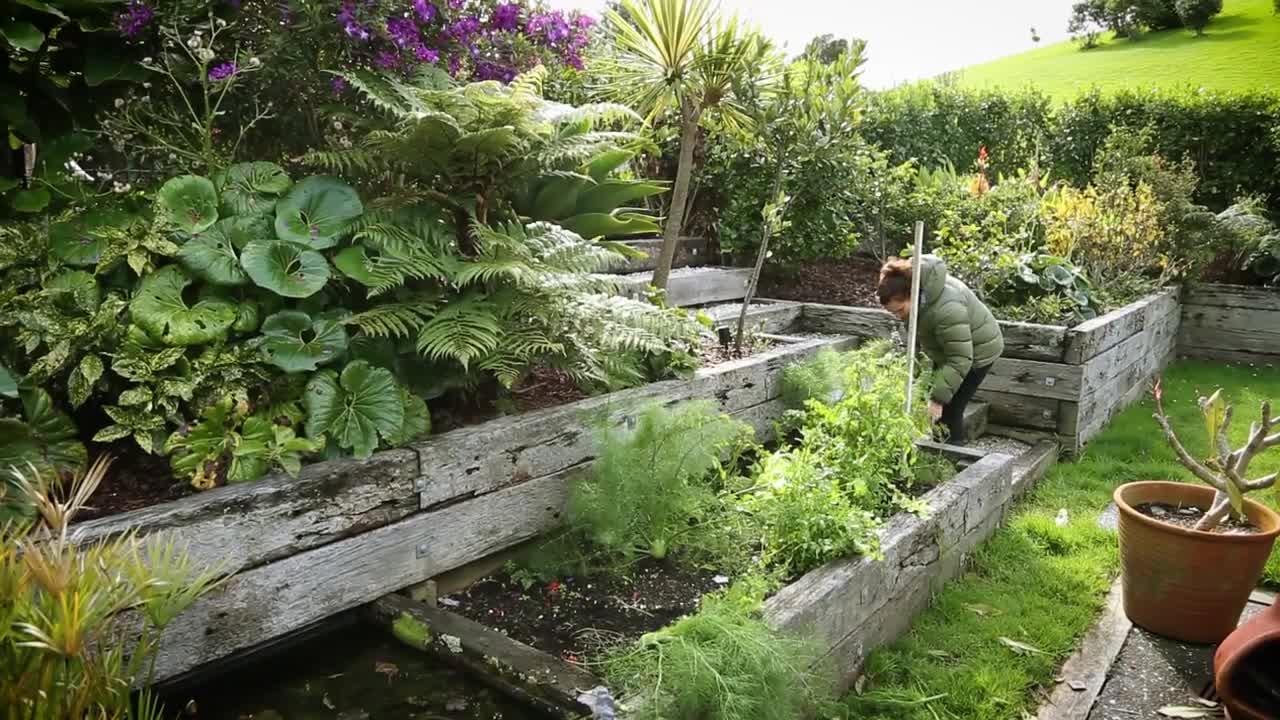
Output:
(801, 288), (1181, 452)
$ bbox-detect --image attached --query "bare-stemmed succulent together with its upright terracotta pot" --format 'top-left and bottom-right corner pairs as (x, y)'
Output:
(1115, 380), (1280, 643)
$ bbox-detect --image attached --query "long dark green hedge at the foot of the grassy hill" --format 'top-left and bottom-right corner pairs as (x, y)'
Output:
(864, 83), (1280, 209)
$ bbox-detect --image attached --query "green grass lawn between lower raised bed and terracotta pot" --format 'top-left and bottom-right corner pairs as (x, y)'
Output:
(846, 363), (1280, 720)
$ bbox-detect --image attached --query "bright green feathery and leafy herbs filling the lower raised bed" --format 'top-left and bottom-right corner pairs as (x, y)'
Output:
(512, 342), (940, 720)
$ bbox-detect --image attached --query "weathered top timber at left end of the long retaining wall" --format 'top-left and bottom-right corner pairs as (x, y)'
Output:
(73, 448), (419, 573)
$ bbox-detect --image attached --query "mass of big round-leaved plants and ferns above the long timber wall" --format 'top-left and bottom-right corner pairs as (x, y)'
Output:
(0, 72), (701, 499)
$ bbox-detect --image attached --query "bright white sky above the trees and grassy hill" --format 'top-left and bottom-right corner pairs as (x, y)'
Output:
(549, 0), (1073, 88)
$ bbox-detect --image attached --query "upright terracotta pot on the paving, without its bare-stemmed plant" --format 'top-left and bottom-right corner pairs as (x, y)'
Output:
(1115, 482), (1280, 644)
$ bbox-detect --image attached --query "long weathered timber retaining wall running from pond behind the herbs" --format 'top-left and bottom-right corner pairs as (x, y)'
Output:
(76, 338), (855, 680)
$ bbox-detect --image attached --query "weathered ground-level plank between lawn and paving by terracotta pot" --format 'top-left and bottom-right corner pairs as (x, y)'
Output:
(1036, 580), (1133, 720)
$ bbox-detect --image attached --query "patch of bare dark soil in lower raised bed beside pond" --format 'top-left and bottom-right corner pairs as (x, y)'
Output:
(443, 559), (724, 662)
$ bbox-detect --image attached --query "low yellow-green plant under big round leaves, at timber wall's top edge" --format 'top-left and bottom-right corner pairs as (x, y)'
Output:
(164, 396), (324, 489)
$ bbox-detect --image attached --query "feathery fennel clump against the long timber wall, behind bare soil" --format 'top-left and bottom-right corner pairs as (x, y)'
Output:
(568, 401), (750, 559)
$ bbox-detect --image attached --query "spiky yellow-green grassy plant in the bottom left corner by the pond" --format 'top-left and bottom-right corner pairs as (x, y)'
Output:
(0, 459), (220, 720)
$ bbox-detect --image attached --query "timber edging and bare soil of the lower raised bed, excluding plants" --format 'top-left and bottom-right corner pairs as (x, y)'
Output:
(374, 435), (1056, 716)
